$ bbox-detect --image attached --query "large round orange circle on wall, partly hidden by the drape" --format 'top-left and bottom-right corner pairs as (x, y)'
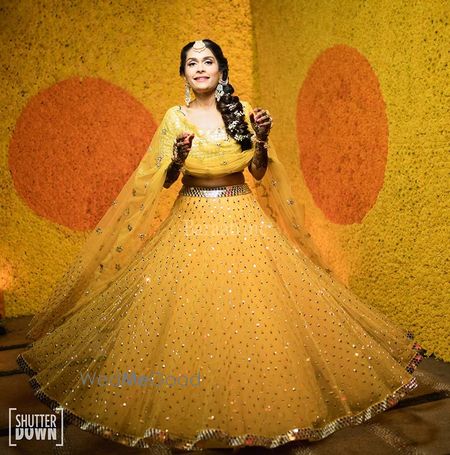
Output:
(9, 77), (156, 230)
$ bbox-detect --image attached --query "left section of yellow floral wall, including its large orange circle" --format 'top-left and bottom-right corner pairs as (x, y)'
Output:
(0, 0), (253, 317)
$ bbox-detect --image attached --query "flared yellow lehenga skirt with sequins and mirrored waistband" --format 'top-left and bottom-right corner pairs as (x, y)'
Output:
(17, 184), (421, 450)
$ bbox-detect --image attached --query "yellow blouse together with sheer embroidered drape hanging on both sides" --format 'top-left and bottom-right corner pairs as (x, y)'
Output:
(28, 101), (332, 339)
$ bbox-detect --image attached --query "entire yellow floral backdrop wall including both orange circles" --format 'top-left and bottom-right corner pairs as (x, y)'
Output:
(0, 0), (450, 360)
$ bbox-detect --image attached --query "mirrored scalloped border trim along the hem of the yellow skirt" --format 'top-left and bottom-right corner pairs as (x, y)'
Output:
(16, 343), (425, 451)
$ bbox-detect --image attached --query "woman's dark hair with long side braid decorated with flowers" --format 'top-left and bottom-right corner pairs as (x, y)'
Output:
(180, 39), (252, 151)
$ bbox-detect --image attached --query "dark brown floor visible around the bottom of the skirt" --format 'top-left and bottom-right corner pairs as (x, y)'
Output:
(0, 317), (450, 455)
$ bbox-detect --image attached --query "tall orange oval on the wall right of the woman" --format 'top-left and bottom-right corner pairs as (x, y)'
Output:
(297, 45), (388, 224)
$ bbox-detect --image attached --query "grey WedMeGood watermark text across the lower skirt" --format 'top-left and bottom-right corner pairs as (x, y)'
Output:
(80, 370), (201, 387)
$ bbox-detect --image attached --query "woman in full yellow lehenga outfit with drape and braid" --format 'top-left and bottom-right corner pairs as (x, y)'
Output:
(17, 39), (422, 450)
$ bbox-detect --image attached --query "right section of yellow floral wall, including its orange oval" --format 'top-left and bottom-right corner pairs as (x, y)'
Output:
(251, 0), (450, 360)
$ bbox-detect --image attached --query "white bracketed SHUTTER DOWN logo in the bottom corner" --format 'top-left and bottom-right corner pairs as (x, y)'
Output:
(8, 408), (64, 447)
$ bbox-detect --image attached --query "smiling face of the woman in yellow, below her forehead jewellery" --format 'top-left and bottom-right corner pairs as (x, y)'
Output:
(184, 47), (221, 93)
